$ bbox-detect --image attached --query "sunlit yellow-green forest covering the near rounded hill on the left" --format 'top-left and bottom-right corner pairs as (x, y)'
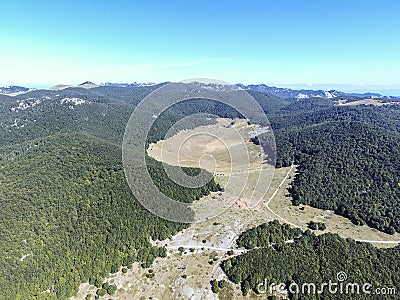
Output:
(0, 133), (216, 299)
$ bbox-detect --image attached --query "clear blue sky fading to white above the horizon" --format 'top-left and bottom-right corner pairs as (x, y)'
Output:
(0, 0), (400, 94)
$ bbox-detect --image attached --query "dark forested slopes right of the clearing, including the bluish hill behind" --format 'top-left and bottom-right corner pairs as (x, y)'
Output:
(270, 99), (400, 234)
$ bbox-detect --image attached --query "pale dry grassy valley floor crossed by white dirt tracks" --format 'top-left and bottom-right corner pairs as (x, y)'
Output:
(72, 119), (400, 300)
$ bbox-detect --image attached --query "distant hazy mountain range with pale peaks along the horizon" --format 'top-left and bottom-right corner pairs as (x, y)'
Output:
(0, 81), (399, 100)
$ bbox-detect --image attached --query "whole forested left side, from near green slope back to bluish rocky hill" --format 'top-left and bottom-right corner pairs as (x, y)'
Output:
(0, 87), (222, 299)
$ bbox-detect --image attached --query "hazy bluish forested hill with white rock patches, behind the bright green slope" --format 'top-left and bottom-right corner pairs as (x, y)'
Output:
(0, 87), (155, 145)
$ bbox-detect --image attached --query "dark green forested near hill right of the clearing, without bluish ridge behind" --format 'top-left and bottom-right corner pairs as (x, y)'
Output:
(277, 122), (400, 233)
